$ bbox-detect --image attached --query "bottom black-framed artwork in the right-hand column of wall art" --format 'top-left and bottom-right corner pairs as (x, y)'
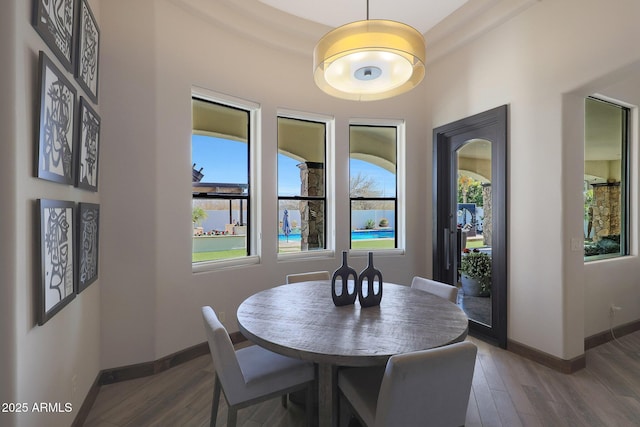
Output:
(76, 203), (100, 293)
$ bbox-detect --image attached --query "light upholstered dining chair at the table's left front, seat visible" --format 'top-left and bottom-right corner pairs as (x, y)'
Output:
(202, 306), (315, 427)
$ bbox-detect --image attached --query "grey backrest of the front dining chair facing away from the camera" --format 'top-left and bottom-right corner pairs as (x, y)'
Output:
(375, 341), (478, 427)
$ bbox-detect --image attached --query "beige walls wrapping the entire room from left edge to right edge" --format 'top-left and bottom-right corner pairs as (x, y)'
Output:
(0, 0), (640, 426)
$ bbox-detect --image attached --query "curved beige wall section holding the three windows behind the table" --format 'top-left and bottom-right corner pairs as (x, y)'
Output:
(101, 1), (431, 367)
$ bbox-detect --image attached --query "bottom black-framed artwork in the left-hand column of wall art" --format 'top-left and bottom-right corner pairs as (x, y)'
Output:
(38, 199), (75, 325)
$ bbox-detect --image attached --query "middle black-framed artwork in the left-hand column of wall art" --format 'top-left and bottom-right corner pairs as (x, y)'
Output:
(36, 51), (76, 185)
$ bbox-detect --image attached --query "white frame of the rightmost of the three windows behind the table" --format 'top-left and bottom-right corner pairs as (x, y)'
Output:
(347, 118), (406, 256)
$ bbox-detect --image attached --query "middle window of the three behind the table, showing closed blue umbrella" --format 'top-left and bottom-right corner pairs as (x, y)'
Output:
(278, 117), (327, 253)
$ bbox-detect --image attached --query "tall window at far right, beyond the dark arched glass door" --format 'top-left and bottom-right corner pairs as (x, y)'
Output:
(584, 97), (629, 261)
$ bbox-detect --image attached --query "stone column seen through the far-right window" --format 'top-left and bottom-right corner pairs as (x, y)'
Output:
(591, 182), (621, 242)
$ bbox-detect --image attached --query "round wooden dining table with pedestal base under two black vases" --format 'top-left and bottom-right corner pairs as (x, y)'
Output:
(237, 280), (468, 427)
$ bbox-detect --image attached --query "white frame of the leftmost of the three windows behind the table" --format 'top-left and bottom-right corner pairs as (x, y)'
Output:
(190, 87), (262, 273)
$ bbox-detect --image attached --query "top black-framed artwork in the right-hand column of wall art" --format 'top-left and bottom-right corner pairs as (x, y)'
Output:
(75, 0), (100, 104)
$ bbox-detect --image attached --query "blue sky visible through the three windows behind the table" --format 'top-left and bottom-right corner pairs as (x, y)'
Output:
(191, 135), (395, 196)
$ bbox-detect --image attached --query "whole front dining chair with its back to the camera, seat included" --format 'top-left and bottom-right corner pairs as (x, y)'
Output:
(338, 341), (478, 427)
